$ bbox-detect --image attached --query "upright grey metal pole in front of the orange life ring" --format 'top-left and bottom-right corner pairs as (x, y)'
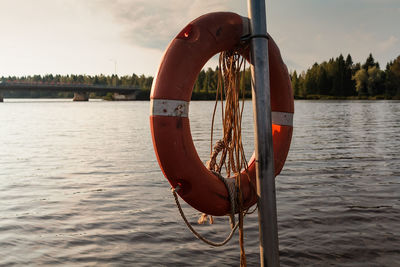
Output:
(248, 0), (279, 267)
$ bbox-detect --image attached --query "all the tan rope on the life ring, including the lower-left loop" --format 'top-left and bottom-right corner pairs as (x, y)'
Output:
(172, 51), (253, 267)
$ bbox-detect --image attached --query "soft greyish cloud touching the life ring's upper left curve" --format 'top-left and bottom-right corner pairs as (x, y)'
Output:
(94, 0), (232, 50)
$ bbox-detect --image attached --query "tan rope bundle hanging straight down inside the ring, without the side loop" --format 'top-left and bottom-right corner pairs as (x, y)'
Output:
(207, 51), (247, 266)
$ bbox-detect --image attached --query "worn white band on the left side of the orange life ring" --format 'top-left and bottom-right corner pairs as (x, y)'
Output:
(150, 99), (189, 117)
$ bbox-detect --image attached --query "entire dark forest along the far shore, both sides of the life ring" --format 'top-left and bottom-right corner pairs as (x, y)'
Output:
(0, 54), (400, 100)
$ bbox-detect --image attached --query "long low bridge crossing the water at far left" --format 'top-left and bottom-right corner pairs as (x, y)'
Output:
(0, 81), (141, 102)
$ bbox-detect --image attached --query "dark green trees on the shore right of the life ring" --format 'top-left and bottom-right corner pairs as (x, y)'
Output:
(291, 54), (400, 99)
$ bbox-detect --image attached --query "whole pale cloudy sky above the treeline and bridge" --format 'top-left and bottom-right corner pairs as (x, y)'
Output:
(0, 0), (400, 76)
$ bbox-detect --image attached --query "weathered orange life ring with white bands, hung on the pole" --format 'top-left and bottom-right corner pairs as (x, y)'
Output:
(150, 12), (294, 216)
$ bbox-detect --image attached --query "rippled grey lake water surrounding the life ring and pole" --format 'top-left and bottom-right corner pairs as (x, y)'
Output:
(0, 99), (400, 266)
